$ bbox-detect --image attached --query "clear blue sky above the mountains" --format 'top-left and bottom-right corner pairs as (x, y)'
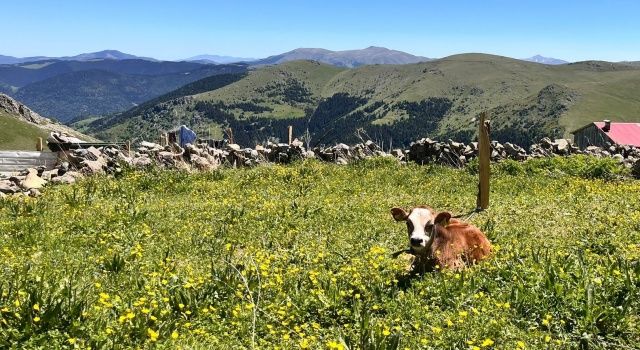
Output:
(0, 0), (640, 61)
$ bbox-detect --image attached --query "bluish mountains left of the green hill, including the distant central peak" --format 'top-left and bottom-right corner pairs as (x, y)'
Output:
(0, 47), (438, 122)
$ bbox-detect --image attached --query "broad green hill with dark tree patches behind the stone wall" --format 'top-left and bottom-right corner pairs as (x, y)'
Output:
(89, 54), (640, 146)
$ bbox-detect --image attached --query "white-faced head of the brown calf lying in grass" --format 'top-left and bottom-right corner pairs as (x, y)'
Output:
(391, 207), (435, 252)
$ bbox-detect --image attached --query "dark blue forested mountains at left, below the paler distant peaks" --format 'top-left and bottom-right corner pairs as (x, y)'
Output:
(0, 56), (247, 122)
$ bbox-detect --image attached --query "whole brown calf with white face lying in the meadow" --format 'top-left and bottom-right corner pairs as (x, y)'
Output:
(391, 206), (491, 271)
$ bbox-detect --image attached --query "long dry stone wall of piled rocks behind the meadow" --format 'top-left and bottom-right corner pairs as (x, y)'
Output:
(0, 138), (640, 197)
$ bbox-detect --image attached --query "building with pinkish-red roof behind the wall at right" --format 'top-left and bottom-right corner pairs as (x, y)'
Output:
(572, 120), (640, 148)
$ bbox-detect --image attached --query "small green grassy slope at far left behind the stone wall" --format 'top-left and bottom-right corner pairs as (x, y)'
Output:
(0, 111), (49, 151)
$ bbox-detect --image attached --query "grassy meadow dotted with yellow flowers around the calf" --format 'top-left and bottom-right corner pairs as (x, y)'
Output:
(0, 157), (640, 349)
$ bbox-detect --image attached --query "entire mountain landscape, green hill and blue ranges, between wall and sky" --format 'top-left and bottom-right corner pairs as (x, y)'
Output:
(5, 47), (640, 146)
